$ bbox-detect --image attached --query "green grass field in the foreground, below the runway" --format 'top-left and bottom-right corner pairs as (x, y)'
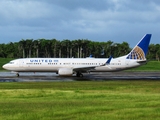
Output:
(0, 80), (160, 120)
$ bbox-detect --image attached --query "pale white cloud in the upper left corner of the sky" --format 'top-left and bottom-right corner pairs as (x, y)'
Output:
(0, 0), (51, 19)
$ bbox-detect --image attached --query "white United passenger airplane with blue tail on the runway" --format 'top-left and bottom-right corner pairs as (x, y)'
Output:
(2, 34), (152, 77)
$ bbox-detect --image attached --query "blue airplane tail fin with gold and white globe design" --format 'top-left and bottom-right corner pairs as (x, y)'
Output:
(126, 34), (152, 60)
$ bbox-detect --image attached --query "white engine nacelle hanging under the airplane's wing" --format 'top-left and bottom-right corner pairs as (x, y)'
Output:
(58, 68), (73, 76)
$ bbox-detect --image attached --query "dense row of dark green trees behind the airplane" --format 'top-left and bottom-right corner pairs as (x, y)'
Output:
(0, 39), (160, 61)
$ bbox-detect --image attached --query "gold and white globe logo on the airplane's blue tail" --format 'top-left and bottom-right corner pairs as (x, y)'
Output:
(127, 46), (146, 60)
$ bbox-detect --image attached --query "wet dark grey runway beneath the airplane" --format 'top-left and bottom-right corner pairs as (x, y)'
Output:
(0, 71), (160, 82)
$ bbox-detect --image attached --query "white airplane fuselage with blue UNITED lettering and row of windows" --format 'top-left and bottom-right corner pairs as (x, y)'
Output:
(3, 57), (141, 72)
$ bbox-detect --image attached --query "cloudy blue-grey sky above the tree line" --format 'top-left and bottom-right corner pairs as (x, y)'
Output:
(0, 0), (160, 47)
